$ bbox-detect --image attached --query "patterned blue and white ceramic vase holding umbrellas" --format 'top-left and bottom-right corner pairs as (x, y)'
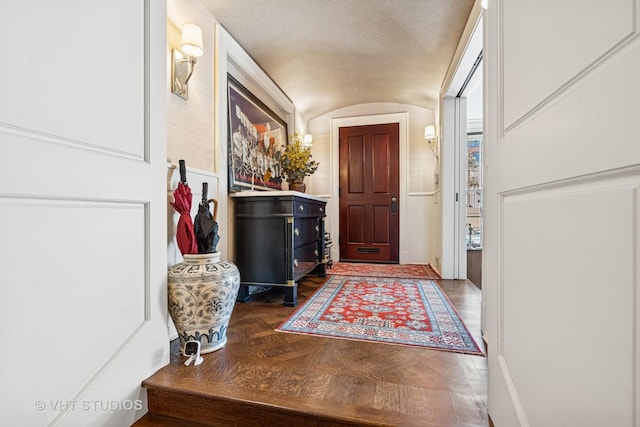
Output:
(168, 252), (240, 354)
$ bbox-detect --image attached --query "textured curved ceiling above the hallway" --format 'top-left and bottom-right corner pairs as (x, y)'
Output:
(201, 0), (474, 120)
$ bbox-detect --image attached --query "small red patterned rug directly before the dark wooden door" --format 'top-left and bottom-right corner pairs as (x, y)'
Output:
(327, 262), (441, 280)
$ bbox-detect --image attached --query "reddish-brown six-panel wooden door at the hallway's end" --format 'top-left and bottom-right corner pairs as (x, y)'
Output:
(340, 123), (399, 262)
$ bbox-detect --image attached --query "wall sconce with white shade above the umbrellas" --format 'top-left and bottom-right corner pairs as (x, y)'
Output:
(171, 22), (204, 99)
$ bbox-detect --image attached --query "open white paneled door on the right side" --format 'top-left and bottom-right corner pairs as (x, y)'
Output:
(482, 0), (640, 427)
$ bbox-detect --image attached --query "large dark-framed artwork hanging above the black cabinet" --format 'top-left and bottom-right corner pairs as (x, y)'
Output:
(227, 75), (288, 192)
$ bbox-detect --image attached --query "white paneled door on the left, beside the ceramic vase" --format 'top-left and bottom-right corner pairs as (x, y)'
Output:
(0, 0), (169, 426)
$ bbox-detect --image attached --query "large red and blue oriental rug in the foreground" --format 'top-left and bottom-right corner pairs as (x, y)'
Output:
(276, 276), (483, 355)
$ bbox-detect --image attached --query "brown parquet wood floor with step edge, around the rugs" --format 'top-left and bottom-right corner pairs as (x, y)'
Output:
(135, 276), (489, 427)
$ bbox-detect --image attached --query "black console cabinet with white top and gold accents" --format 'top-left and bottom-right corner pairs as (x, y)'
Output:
(232, 191), (327, 307)
